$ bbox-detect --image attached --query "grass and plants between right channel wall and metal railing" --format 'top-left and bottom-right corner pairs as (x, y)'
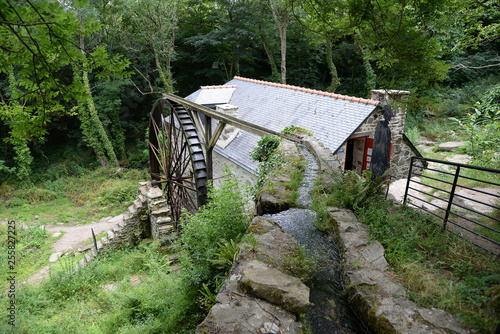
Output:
(313, 174), (500, 333)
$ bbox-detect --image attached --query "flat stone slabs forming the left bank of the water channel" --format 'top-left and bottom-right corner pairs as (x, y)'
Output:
(196, 217), (309, 334)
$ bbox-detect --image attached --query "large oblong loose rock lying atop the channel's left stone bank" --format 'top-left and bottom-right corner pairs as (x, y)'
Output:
(240, 261), (309, 314)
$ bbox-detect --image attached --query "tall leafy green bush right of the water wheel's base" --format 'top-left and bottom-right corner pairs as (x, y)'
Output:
(181, 176), (248, 285)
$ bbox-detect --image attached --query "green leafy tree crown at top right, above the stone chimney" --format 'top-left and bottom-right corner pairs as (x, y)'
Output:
(348, 0), (449, 87)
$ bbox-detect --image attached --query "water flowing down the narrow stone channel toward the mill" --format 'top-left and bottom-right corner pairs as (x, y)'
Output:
(264, 148), (370, 334)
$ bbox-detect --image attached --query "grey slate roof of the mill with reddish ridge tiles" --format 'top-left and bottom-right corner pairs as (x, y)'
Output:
(186, 77), (378, 175)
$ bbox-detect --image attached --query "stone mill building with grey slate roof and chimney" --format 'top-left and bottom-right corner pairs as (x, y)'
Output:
(186, 76), (420, 184)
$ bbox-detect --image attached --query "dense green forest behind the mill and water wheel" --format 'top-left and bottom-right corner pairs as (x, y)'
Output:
(0, 0), (500, 183)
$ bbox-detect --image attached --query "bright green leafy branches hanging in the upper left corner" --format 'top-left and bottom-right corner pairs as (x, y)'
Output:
(0, 0), (131, 179)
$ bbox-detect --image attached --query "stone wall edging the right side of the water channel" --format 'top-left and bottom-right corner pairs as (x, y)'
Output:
(328, 208), (469, 334)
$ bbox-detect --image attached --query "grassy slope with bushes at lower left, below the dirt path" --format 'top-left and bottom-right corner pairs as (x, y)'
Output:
(0, 174), (248, 334)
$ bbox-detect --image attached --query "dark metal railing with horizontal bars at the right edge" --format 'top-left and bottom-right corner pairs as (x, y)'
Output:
(403, 157), (500, 256)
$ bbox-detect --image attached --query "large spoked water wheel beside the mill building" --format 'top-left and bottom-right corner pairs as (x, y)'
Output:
(149, 99), (207, 222)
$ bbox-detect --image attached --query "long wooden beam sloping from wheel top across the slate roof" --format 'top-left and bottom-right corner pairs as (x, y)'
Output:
(163, 93), (302, 143)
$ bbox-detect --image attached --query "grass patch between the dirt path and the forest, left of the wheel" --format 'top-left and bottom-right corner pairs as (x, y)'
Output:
(0, 168), (148, 224)
